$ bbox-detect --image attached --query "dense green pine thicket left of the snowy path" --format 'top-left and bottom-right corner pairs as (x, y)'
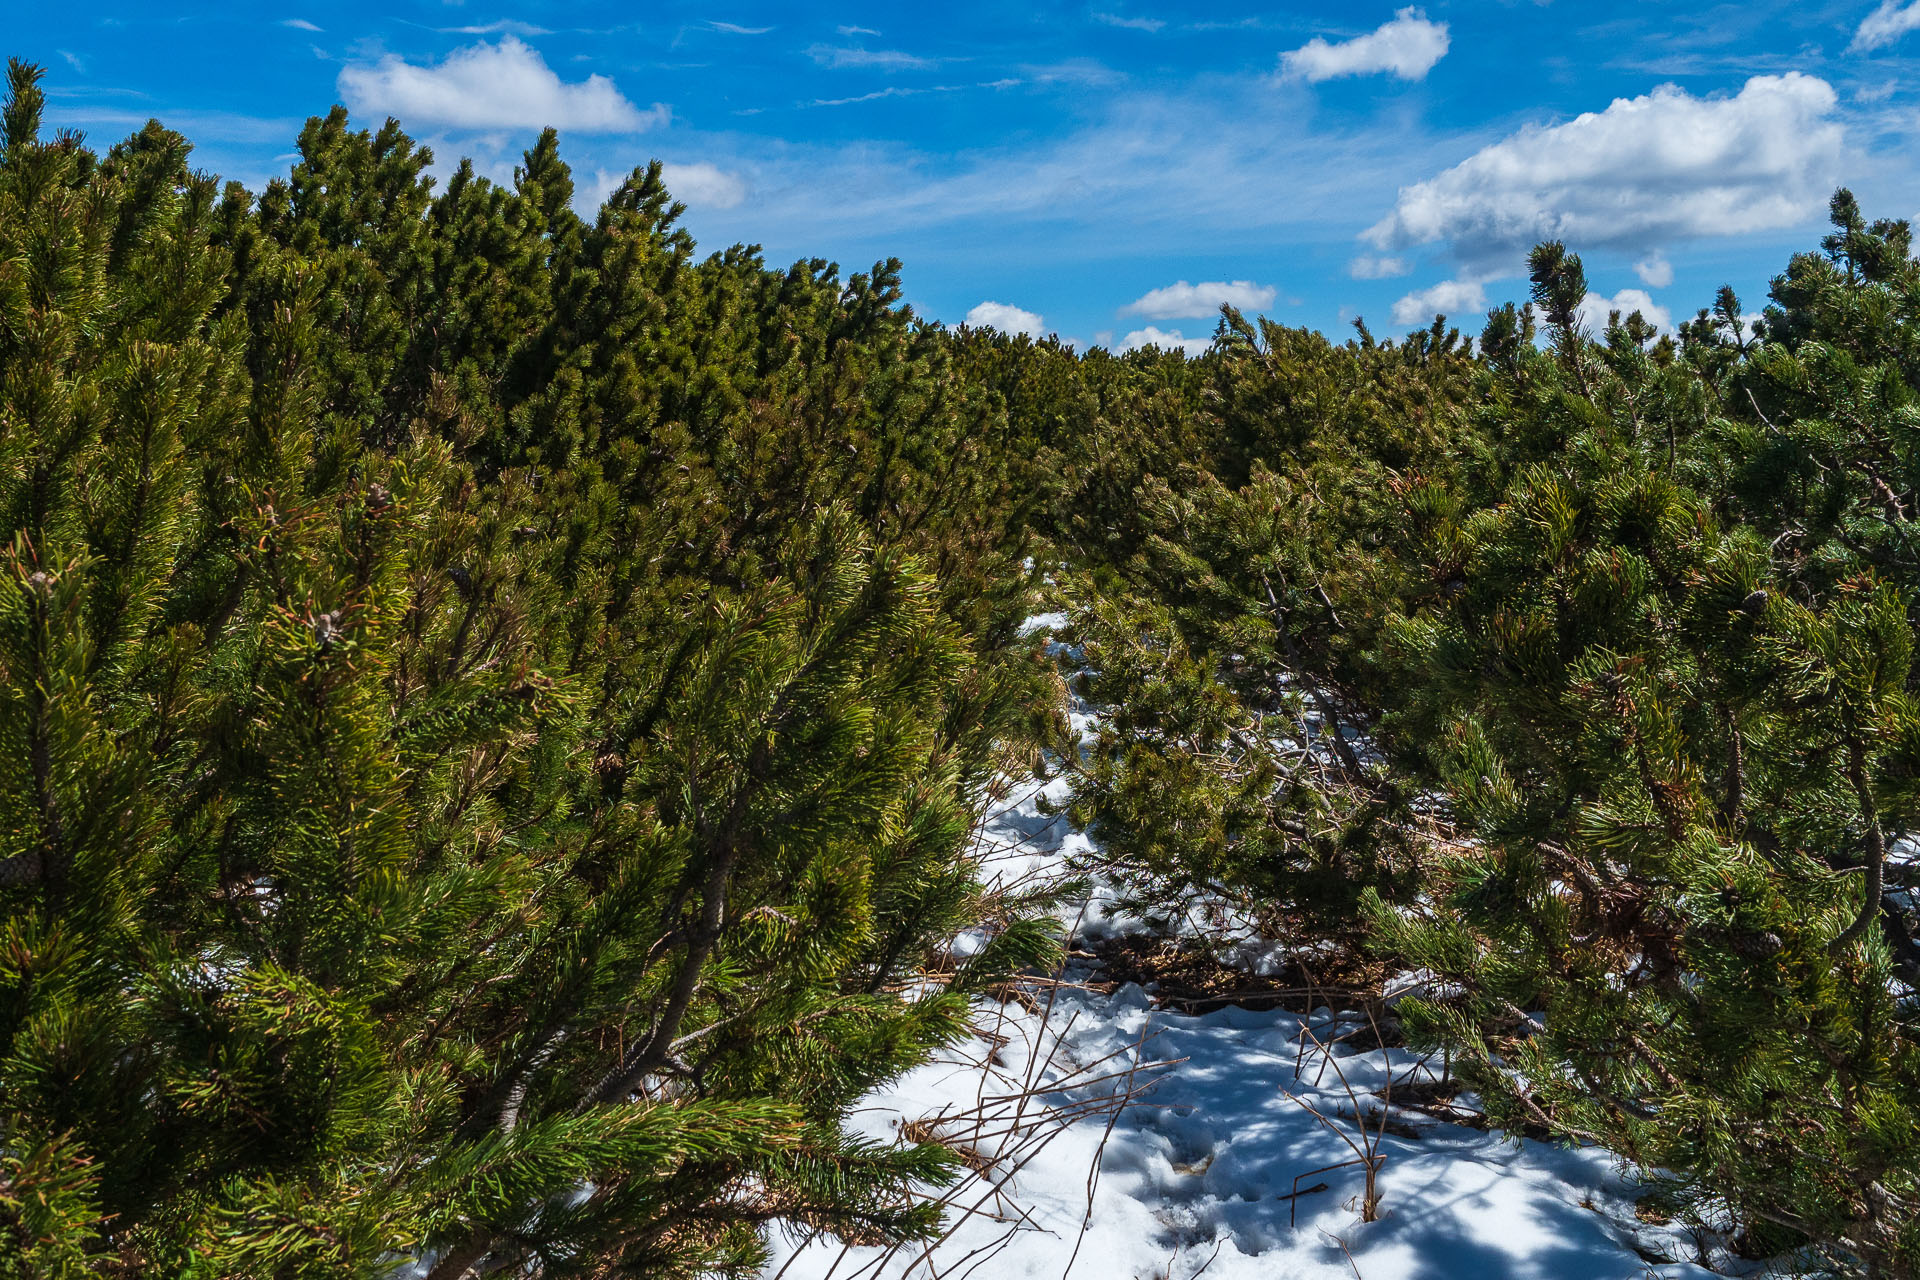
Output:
(0, 63), (1058, 1280)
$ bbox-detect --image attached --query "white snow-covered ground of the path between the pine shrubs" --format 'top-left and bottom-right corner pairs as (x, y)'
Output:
(768, 620), (1713, 1280)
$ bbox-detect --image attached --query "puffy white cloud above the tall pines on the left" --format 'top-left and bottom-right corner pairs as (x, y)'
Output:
(338, 36), (668, 132)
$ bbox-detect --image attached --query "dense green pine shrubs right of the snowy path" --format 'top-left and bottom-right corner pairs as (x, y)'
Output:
(1077, 192), (1920, 1274)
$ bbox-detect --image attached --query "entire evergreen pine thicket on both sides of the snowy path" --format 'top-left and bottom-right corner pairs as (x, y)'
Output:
(0, 55), (1920, 1280)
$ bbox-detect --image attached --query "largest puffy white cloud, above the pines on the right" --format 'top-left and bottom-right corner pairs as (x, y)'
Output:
(1365, 71), (1843, 263)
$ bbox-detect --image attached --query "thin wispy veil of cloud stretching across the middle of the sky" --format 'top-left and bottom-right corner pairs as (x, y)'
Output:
(664, 79), (1434, 255)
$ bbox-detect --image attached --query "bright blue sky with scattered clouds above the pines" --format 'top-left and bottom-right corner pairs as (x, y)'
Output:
(22, 0), (1920, 345)
